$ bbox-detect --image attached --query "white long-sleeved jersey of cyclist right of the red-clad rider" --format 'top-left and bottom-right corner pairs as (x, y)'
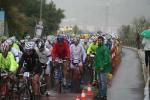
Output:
(70, 44), (86, 63)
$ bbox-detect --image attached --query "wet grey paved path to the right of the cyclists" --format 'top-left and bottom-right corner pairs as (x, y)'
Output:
(108, 48), (144, 100)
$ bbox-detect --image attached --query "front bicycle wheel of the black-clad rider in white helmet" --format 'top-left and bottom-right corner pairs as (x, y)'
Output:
(19, 84), (31, 100)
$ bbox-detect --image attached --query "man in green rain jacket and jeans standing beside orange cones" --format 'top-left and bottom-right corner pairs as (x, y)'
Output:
(94, 36), (112, 100)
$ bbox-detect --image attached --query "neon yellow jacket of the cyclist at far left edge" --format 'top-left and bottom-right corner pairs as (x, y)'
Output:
(0, 52), (18, 72)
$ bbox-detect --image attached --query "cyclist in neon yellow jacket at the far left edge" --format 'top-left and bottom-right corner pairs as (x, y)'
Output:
(0, 42), (18, 95)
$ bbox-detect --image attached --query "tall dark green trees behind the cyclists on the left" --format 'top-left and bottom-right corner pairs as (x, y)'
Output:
(0, 0), (65, 37)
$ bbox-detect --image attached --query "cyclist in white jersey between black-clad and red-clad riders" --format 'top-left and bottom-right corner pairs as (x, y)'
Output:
(35, 40), (55, 95)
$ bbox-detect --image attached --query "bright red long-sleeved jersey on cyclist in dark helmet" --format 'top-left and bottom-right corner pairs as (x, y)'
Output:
(52, 41), (70, 59)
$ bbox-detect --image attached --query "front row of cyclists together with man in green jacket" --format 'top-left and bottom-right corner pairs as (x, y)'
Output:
(0, 32), (116, 100)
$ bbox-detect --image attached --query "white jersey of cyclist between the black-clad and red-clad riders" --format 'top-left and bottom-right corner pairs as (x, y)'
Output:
(35, 47), (50, 64)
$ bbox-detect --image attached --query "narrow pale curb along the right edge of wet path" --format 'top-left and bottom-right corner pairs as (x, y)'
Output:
(122, 46), (148, 84)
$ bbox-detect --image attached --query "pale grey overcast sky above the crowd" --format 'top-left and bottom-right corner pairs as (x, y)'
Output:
(49, 0), (150, 31)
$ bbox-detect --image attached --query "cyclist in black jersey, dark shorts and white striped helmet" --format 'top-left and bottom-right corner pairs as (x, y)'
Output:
(19, 41), (42, 99)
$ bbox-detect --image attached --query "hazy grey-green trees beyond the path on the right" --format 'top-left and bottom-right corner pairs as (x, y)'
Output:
(118, 16), (150, 48)
